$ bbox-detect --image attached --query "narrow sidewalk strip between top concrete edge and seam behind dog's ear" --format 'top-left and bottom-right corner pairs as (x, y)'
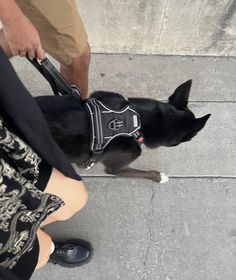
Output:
(12, 54), (236, 103)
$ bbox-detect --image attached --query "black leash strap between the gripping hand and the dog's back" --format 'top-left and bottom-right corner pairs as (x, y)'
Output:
(26, 56), (80, 96)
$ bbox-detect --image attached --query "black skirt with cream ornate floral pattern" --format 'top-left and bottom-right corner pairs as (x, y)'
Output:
(0, 116), (64, 280)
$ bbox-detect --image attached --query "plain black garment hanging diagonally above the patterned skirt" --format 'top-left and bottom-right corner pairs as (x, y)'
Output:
(0, 48), (81, 183)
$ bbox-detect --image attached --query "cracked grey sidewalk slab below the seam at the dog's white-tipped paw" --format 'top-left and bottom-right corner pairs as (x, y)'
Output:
(30, 178), (236, 280)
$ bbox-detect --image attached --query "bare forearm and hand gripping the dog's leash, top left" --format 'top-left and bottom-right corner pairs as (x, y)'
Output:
(0, 0), (45, 60)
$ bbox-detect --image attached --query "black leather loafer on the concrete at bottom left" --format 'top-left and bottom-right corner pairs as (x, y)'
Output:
(49, 239), (93, 267)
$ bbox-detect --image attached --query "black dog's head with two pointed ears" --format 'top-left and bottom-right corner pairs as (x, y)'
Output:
(142, 80), (210, 148)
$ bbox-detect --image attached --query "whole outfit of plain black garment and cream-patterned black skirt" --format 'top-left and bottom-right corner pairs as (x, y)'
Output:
(0, 49), (81, 280)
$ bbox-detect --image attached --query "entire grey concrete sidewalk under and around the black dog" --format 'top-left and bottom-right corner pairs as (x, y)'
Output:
(13, 54), (236, 280)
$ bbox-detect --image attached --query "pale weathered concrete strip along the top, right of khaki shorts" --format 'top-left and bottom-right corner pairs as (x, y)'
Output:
(77, 0), (236, 56)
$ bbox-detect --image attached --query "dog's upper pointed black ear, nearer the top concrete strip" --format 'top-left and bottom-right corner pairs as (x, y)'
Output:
(169, 80), (192, 110)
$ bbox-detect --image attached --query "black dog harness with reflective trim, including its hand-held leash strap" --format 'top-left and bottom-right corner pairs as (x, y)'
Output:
(27, 57), (144, 169)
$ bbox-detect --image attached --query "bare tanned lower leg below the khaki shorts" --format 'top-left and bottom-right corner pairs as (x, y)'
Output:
(60, 41), (91, 98)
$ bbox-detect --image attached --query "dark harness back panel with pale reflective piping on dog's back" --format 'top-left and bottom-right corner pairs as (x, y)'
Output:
(86, 98), (141, 152)
